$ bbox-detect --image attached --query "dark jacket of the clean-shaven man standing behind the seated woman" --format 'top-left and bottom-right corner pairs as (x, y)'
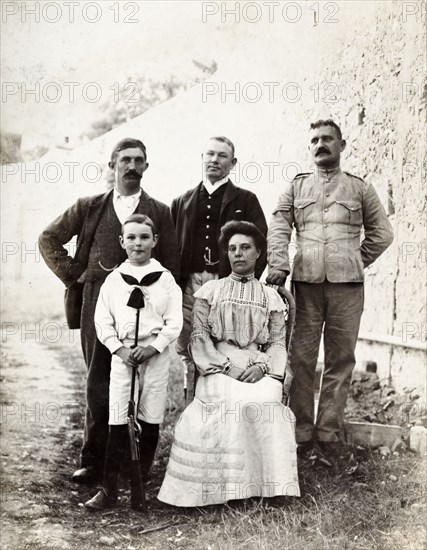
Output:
(171, 180), (267, 290)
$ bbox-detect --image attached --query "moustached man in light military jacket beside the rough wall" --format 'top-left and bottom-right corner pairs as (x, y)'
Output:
(267, 120), (393, 458)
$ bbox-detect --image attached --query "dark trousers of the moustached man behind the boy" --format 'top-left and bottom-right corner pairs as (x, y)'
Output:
(81, 281), (111, 472)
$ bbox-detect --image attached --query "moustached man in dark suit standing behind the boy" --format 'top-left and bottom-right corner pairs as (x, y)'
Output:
(39, 138), (179, 483)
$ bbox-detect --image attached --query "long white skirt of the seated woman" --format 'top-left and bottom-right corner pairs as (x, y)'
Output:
(158, 374), (300, 506)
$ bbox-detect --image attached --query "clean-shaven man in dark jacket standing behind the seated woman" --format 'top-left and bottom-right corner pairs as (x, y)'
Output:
(171, 136), (267, 396)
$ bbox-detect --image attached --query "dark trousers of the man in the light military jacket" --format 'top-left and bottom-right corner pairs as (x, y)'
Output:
(289, 281), (364, 443)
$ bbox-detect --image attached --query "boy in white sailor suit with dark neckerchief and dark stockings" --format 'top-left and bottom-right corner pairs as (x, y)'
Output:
(85, 214), (182, 510)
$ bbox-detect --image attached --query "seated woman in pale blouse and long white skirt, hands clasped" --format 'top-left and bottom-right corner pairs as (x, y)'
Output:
(158, 221), (300, 506)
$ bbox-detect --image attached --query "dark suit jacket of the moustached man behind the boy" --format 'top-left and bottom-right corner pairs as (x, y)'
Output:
(39, 190), (179, 328)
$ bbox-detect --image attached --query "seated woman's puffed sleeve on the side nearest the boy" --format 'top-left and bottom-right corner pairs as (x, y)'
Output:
(189, 298), (228, 376)
